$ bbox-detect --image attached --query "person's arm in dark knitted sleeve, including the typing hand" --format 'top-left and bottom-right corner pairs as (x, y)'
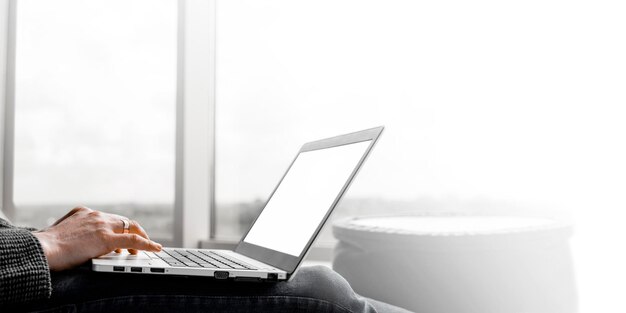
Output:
(0, 207), (161, 306)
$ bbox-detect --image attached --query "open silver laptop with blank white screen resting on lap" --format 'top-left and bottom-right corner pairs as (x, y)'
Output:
(92, 126), (384, 281)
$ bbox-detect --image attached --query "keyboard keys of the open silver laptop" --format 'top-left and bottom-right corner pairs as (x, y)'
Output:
(155, 249), (257, 270)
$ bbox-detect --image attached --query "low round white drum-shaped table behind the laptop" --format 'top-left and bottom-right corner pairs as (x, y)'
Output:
(333, 215), (577, 313)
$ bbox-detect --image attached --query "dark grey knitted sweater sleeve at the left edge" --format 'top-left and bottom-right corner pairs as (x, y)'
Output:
(0, 219), (52, 306)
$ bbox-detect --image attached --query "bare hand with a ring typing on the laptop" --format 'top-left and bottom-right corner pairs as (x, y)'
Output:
(33, 207), (161, 271)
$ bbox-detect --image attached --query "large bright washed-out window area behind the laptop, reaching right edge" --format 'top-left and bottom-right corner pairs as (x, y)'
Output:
(215, 0), (626, 312)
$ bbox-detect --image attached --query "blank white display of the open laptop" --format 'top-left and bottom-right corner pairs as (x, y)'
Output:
(243, 140), (371, 257)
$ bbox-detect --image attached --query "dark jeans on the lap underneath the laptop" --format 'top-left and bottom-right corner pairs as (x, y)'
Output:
(19, 266), (407, 313)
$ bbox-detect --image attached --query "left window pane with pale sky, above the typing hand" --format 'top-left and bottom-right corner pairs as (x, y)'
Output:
(14, 0), (177, 238)
